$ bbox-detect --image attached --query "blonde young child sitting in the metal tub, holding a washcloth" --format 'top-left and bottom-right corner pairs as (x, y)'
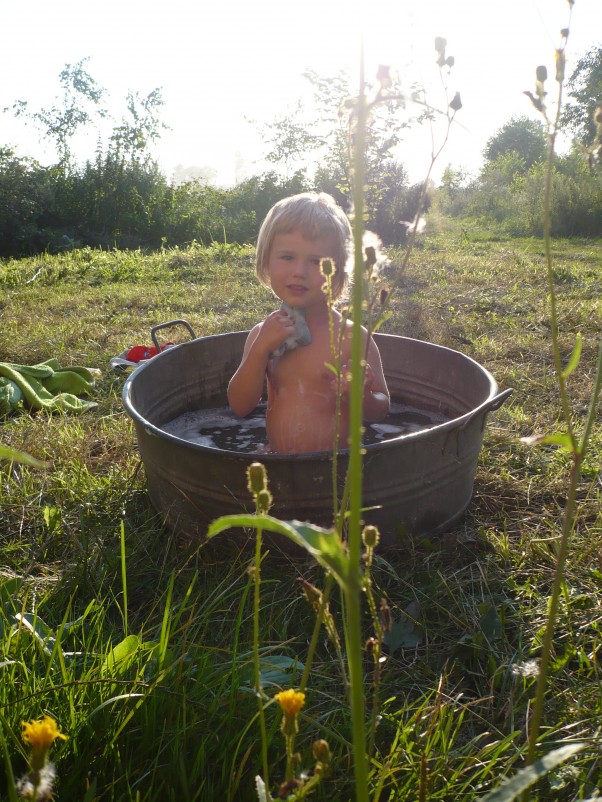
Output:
(228, 193), (389, 454)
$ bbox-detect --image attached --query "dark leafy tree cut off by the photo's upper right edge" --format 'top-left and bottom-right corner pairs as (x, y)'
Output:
(563, 46), (602, 145)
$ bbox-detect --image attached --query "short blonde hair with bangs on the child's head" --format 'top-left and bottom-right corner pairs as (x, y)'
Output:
(255, 192), (352, 300)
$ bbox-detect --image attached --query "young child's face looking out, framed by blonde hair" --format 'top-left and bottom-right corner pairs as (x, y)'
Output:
(267, 231), (336, 309)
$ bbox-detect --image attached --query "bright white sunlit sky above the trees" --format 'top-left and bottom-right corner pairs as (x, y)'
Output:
(0, 0), (602, 186)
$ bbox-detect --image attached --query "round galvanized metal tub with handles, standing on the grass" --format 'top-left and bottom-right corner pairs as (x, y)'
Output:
(123, 331), (512, 547)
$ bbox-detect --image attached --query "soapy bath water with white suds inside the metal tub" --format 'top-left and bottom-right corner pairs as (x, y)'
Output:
(161, 403), (448, 454)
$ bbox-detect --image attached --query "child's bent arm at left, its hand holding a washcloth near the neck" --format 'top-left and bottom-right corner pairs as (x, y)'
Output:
(228, 310), (295, 417)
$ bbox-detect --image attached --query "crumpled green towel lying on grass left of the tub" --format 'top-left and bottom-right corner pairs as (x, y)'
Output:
(0, 359), (99, 415)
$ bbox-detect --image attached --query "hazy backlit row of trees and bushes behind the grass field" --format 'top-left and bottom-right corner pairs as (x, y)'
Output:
(0, 47), (602, 257)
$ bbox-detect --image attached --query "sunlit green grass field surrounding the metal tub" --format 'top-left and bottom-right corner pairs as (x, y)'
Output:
(0, 229), (602, 802)
